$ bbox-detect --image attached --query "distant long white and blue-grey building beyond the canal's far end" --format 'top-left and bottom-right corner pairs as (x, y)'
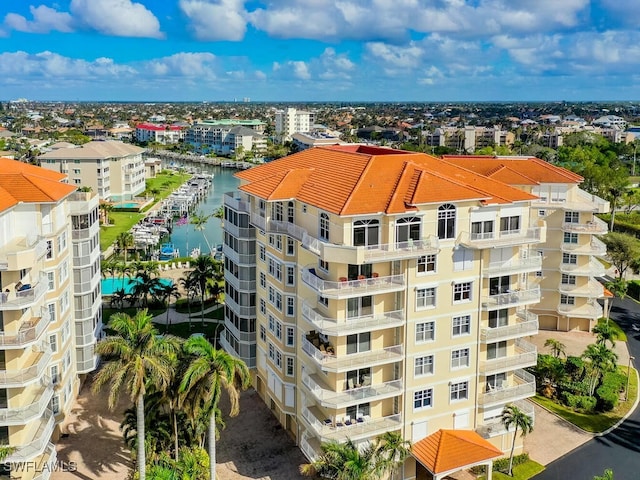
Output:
(185, 120), (267, 155)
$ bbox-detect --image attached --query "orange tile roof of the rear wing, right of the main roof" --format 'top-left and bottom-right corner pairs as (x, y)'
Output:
(442, 155), (583, 185)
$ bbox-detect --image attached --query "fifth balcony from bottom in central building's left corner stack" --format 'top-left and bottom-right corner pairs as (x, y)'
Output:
(302, 267), (406, 299)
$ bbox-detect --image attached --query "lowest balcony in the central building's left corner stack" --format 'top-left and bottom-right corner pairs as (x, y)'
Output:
(302, 407), (402, 442)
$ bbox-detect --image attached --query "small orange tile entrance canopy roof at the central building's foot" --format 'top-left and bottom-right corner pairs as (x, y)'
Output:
(411, 430), (503, 474)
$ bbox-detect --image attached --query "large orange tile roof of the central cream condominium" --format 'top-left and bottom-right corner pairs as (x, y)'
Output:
(236, 145), (537, 215)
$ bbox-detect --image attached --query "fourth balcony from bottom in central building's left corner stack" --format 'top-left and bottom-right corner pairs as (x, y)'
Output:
(302, 302), (404, 337)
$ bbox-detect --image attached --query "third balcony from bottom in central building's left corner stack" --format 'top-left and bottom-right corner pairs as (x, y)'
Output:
(302, 335), (404, 373)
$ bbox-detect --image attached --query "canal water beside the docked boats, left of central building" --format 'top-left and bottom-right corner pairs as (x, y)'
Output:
(170, 163), (240, 257)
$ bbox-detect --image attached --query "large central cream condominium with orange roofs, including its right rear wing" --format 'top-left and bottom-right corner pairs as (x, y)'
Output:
(221, 145), (607, 478)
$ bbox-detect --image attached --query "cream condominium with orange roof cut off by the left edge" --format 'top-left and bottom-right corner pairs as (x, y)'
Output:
(0, 159), (100, 480)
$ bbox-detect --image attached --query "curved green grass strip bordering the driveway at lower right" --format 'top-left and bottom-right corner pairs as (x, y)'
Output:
(532, 366), (638, 433)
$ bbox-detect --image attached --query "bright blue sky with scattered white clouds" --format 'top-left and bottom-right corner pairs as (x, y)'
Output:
(0, 0), (640, 101)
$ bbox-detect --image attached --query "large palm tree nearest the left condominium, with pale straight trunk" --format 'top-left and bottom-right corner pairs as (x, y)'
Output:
(93, 310), (179, 480)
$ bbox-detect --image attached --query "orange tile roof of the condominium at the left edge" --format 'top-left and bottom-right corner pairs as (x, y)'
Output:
(0, 158), (77, 211)
